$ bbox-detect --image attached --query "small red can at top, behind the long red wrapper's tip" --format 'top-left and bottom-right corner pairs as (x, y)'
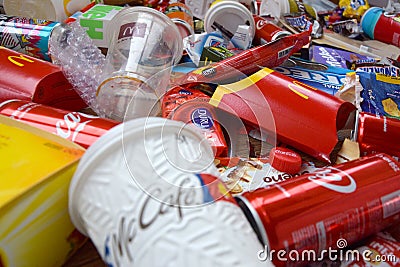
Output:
(253, 15), (292, 45)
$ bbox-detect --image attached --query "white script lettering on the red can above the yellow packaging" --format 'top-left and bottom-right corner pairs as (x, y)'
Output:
(56, 112), (98, 141)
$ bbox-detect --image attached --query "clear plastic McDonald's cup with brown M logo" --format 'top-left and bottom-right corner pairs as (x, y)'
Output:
(96, 6), (183, 121)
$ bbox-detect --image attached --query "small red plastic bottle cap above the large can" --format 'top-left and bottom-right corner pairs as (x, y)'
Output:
(269, 147), (301, 174)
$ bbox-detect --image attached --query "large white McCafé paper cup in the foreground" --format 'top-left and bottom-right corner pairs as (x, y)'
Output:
(69, 117), (271, 267)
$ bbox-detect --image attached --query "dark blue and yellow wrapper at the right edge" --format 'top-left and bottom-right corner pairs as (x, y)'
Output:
(358, 72), (400, 119)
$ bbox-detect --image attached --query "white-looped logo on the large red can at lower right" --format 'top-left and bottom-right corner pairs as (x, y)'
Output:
(308, 167), (357, 194)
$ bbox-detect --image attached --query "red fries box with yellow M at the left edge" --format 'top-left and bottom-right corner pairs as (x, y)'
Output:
(0, 46), (87, 111)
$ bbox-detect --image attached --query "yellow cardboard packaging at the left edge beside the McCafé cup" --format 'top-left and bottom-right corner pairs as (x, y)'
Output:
(0, 116), (85, 267)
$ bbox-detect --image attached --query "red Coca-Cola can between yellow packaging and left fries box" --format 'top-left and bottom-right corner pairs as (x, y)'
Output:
(0, 99), (119, 148)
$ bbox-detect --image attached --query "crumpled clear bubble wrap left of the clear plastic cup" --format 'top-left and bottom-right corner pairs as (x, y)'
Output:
(49, 22), (105, 117)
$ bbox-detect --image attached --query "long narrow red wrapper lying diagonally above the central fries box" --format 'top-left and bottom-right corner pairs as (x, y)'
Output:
(175, 29), (311, 85)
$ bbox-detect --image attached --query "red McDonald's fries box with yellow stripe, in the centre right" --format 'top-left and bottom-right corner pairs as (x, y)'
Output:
(210, 68), (356, 163)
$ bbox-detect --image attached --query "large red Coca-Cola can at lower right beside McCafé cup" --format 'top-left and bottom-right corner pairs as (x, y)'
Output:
(237, 153), (400, 266)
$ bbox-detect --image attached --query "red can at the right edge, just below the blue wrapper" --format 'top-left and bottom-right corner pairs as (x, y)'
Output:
(355, 112), (400, 157)
